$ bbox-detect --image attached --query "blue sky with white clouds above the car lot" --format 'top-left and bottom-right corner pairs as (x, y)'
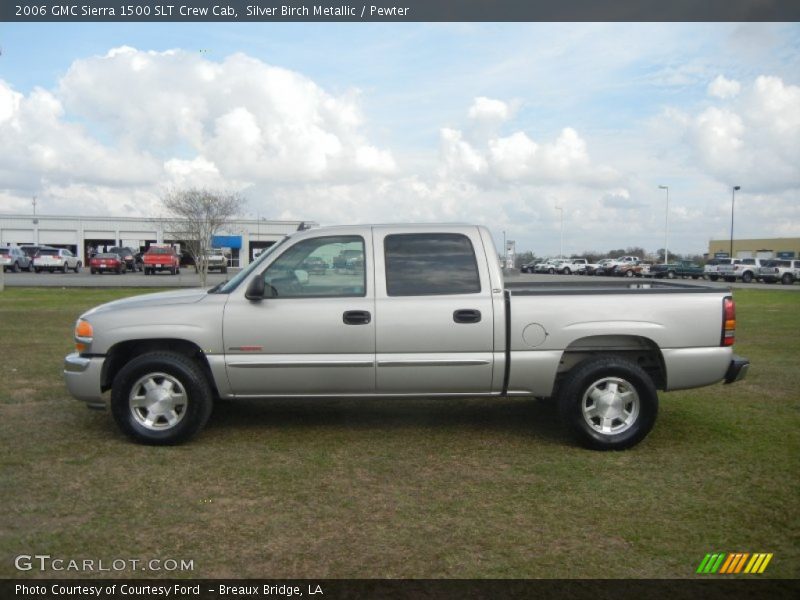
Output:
(0, 23), (800, 255)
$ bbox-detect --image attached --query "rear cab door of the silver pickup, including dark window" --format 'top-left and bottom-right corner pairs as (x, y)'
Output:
(373, 226), (494, 394)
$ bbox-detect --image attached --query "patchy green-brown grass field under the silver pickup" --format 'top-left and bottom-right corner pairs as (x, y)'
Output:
(0, 289), (800, 578)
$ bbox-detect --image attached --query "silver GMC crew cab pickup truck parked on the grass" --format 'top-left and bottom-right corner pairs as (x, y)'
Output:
(64, 225), (749, 449)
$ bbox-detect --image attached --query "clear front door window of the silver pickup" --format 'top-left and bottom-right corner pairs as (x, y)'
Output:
(263, 235), (366, 298)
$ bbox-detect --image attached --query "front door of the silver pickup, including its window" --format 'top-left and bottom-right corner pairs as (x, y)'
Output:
(223, 228), (375, 396)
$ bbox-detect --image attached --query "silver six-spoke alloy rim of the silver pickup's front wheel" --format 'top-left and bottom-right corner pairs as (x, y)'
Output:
(128, 373), (189, 431)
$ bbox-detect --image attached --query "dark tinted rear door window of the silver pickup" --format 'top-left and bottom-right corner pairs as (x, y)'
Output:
(383, 233), (481, 296)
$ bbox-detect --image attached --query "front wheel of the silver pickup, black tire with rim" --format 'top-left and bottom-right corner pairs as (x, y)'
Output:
(111, 352), (213, 446)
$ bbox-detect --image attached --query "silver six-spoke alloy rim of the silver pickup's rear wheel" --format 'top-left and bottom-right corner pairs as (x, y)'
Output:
(581, 377), (640, 435)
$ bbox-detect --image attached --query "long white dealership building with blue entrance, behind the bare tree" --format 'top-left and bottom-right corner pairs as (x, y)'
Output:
(0, 214), (317, 267)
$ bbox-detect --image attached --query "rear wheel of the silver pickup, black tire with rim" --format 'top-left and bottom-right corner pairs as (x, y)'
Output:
(558, 356), (658, 450)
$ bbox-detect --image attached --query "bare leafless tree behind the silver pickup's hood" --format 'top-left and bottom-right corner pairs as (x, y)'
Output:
(162, 188), (244, 287)
